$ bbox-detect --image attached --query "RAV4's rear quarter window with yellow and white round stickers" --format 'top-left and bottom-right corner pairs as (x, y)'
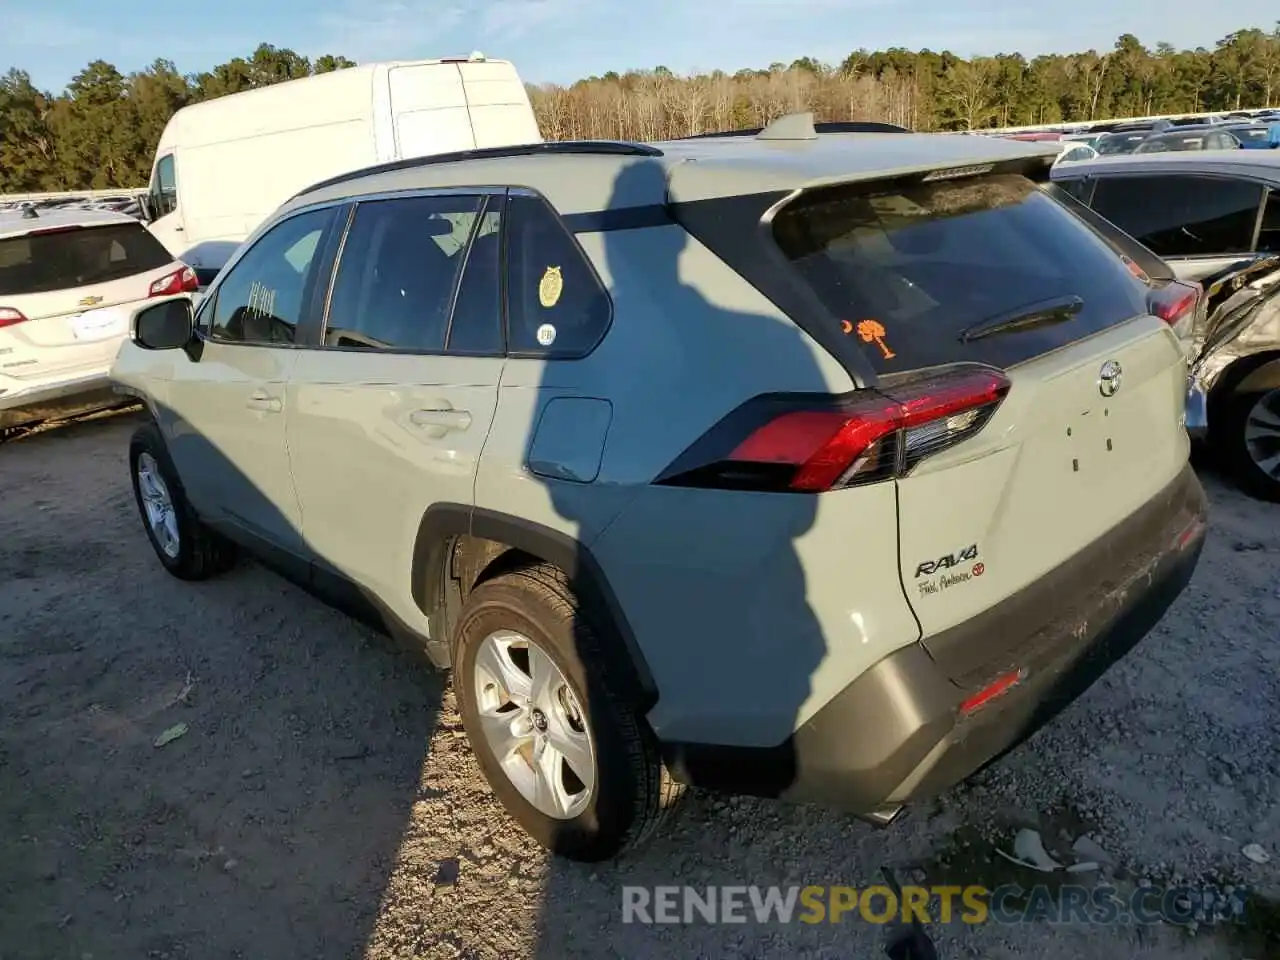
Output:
(507, 196), (613, 358)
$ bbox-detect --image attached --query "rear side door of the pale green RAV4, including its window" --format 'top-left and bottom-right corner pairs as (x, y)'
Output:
(287, 189), (506, 627)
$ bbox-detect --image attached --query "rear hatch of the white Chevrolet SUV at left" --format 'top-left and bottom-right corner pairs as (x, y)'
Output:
(0, 221), (182, 380)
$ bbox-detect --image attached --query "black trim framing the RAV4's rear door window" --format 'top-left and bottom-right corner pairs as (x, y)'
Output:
(308, 186), (508, 360)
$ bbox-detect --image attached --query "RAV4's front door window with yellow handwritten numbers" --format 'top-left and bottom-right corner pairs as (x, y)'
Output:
(209, 209), (334, 343)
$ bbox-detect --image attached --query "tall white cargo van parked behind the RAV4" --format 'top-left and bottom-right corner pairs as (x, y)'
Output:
(146, 54), (541, 285)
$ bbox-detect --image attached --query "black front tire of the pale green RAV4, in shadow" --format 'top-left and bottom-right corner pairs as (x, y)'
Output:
(129, 422), (236, 580)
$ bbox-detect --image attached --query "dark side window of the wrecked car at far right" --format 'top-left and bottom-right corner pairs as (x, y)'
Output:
(1092, 175), (1262, 256)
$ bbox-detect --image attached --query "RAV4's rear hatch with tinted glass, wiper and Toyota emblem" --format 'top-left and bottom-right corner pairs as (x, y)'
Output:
(774, 173), (1188, 684)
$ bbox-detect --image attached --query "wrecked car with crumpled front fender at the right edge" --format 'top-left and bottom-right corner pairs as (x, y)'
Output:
(1052, 150), (1280, 502)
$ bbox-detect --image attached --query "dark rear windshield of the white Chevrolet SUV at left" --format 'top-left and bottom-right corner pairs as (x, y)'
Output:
(0, 223), (173, 296)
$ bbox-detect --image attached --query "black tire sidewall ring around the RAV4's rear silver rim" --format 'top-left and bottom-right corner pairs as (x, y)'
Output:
(453, 577), (639, 860)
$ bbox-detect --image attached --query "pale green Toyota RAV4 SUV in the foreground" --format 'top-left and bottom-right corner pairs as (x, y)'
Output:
(113, 115), (1204, 860)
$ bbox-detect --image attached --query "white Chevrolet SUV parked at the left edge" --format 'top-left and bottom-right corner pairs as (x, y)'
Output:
(0, 207), (197, 431)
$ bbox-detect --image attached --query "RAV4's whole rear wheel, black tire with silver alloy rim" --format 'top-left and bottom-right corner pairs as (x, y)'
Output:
(453, 564), (678, 861)
